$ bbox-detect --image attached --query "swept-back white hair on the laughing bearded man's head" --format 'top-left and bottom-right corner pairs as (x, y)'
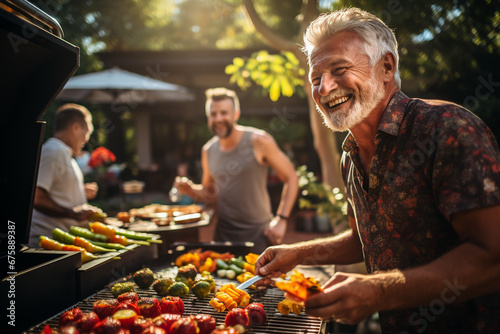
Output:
(302, 8), (401, 88)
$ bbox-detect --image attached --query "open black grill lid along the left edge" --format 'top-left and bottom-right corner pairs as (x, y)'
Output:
(0, 0), (79, 248)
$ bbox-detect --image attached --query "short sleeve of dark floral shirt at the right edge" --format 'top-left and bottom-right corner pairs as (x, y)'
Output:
(432, 106), (500, 220)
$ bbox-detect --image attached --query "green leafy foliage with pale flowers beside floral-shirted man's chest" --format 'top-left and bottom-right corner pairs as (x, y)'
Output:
(297, 165), (347, 222)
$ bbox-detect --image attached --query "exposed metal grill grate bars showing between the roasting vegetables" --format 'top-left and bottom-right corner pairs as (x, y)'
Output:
(28, 269), (322, 334)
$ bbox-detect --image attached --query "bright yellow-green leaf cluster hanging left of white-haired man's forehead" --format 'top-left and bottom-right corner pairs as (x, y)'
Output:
(225, 50), (305, 101)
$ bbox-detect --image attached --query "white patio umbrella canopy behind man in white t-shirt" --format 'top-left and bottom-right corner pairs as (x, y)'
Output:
(57, 68), (194, 104)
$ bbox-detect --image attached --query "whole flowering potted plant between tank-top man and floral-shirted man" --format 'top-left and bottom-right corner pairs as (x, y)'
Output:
(296, 165), (347, 232)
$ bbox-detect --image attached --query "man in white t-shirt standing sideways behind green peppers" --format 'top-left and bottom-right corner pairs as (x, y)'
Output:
(29, 103), (97, 247)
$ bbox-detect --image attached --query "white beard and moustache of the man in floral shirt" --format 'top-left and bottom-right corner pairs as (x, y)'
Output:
(316, 75), (384, 132)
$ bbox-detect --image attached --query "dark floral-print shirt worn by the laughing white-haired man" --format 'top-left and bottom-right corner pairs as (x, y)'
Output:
(342, 92), (500, 333)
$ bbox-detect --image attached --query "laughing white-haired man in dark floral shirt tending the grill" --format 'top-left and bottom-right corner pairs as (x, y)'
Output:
(256, 8), (500, 334)
